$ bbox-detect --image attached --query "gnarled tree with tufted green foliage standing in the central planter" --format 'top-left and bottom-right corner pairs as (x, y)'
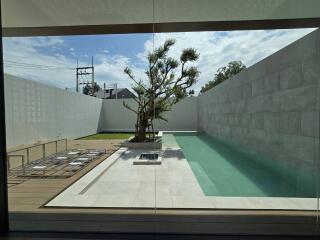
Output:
(123, 39), (199, 142)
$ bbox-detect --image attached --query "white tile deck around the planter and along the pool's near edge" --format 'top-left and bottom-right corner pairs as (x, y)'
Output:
(46, 146), (317, 210)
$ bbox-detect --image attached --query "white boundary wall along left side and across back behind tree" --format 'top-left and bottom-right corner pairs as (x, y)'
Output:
(5, 74), (198, 147)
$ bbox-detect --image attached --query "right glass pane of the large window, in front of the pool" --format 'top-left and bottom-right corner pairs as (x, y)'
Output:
(154, 1), (319, 234)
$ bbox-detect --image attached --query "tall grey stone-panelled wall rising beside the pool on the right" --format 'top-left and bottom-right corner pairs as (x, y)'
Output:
(198, 30), (320, 193)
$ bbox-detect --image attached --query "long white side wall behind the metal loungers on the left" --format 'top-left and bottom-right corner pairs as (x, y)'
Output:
(5, 74), (102, 147)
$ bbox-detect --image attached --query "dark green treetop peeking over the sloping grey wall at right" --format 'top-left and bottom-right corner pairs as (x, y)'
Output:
(200, 61), (246, 93)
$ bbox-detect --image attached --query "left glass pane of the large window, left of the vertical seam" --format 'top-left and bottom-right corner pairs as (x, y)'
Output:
(3, 1), (156, 233)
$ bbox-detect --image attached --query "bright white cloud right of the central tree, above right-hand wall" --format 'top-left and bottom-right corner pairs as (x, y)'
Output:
(138, 29), (314, 91)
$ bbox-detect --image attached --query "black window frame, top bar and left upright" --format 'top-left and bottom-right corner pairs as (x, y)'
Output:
(0, 1), (320, 236)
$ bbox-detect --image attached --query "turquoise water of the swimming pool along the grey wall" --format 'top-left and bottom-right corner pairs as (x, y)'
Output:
(164, 133), (315, 197)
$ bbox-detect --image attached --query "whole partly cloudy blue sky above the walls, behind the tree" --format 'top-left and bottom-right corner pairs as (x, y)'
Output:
(3, 28), (315, 93)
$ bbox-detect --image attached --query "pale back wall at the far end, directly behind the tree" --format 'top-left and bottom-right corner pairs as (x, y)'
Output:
(99, 97), (198, 132)
